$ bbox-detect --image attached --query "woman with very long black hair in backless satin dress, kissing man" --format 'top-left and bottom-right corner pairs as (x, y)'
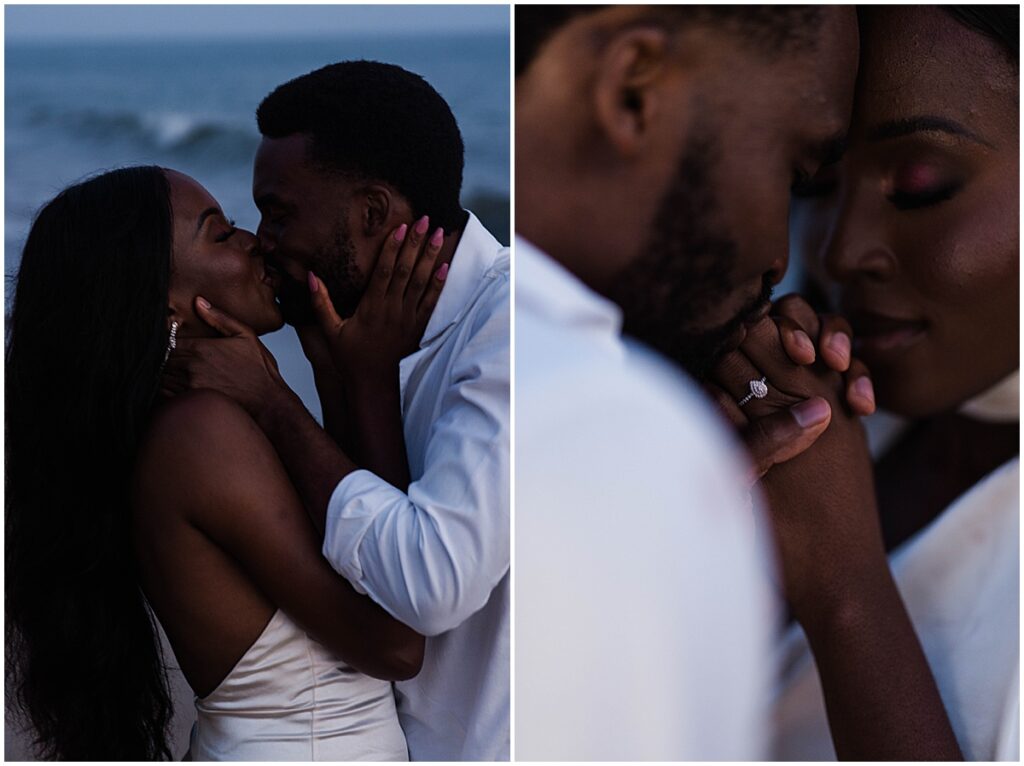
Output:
(5, 167), (439, 760)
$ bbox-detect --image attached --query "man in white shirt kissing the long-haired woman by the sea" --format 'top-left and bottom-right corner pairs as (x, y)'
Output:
(165, 61), (510, 761)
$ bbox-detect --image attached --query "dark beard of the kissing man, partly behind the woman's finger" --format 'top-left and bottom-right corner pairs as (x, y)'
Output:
(278, 211), (366, 327)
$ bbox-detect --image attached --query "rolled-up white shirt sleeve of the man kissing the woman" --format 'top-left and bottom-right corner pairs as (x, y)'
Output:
(324, 296), (510, 636)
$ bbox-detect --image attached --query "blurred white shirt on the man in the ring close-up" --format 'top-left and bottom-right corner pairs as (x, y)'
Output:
(514, 239), (776, 761)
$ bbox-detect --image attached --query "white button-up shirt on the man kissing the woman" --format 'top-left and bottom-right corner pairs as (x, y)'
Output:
(324, 215), (510, 761)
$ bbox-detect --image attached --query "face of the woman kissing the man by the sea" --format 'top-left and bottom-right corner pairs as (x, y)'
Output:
(167, 170), (284, 336)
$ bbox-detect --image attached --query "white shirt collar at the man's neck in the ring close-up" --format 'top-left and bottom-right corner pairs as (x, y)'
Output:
(515, 236), (623, 336)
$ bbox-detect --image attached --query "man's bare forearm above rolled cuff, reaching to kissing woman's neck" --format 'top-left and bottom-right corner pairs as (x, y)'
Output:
(256, 387), (358, 536)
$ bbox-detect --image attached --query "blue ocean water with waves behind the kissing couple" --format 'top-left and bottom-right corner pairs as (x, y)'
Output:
(4, 33), (509, 417)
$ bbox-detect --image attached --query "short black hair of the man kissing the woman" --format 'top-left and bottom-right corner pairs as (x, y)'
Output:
(256, 61), (464, 231)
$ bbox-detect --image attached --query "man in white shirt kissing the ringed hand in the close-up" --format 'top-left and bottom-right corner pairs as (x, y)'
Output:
(515, 5), (857, 760)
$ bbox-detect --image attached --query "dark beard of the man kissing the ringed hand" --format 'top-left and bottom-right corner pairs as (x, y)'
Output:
(609, 118), (771, 380)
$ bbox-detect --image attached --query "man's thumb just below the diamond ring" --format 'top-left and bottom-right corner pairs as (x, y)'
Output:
(743, 396), (831, 481)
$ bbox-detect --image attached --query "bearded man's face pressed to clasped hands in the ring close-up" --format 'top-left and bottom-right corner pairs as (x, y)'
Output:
(609, 9), (857, 378)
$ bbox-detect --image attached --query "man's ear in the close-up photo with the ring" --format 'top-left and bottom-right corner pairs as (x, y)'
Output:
(593, 26), (672, 156)
